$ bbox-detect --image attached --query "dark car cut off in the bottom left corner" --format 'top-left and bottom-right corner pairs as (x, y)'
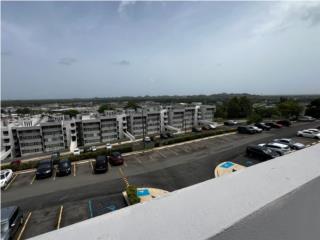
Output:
(1, 206), (23, 240)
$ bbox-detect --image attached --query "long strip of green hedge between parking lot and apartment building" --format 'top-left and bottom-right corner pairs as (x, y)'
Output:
(1, 128), (236, 171)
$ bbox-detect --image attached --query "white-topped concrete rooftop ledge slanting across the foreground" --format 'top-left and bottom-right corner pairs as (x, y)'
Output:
(33, 144), (320, 240)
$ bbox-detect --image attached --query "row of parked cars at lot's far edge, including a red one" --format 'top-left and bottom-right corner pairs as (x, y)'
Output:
(238, 120), (291, 134)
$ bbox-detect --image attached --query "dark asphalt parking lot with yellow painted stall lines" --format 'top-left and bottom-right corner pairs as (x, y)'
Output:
(2, 121), (318, 239)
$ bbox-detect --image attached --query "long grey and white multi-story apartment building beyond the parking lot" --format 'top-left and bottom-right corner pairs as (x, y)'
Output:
(1, 103), (215, 160)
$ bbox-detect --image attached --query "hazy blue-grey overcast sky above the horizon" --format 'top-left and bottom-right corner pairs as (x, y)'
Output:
(1, 2), (320, 99)
